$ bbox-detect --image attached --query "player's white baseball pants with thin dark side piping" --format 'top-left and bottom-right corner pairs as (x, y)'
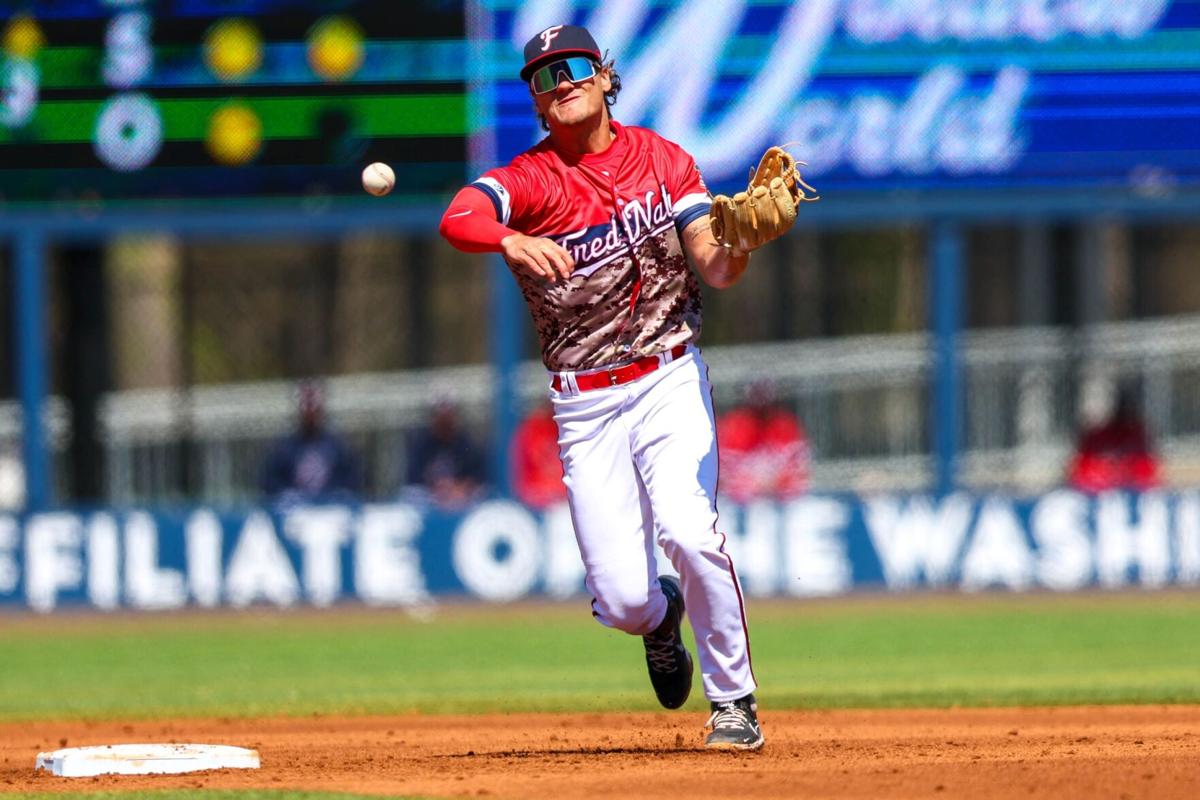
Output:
(551, 347), (756, 703)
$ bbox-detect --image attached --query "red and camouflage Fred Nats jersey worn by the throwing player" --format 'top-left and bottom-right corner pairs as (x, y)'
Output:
(472, 122), (712, 372)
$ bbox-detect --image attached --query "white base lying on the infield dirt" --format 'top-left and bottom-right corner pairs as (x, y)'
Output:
(34, 745), (259, 777)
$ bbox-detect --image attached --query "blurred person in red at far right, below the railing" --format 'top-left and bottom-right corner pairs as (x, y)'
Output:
(1067, 387), (1162, 494)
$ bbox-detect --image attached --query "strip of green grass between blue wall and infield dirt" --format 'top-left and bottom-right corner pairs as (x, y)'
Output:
(0, 593), (1200, 724)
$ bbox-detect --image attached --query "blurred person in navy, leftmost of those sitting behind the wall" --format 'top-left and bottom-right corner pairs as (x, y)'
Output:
(259, 383), (362, 503)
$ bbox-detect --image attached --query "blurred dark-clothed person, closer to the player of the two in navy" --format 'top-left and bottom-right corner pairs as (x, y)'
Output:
(408, 401), (486, 510)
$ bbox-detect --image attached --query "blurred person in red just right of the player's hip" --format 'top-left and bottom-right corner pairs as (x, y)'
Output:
(716, 381), (809, 504)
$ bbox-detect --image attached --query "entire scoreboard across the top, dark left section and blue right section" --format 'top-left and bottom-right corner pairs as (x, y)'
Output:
(11, 0), (1200, 207)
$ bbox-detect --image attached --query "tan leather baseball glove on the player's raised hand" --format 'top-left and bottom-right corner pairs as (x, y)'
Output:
(708, 146), (821, 253)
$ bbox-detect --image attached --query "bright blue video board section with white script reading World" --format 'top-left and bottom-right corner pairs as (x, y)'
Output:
(485, 0), (1200, 197)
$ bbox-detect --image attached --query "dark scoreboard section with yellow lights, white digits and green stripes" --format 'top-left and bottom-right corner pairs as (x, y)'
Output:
(0, 0), (468, 206)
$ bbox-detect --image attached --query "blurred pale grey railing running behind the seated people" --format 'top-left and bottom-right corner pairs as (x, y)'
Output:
(7, 315), (1200, 504)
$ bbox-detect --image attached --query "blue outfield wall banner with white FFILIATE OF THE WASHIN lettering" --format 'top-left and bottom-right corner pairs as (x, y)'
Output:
(0, 491), (1200, 612)
